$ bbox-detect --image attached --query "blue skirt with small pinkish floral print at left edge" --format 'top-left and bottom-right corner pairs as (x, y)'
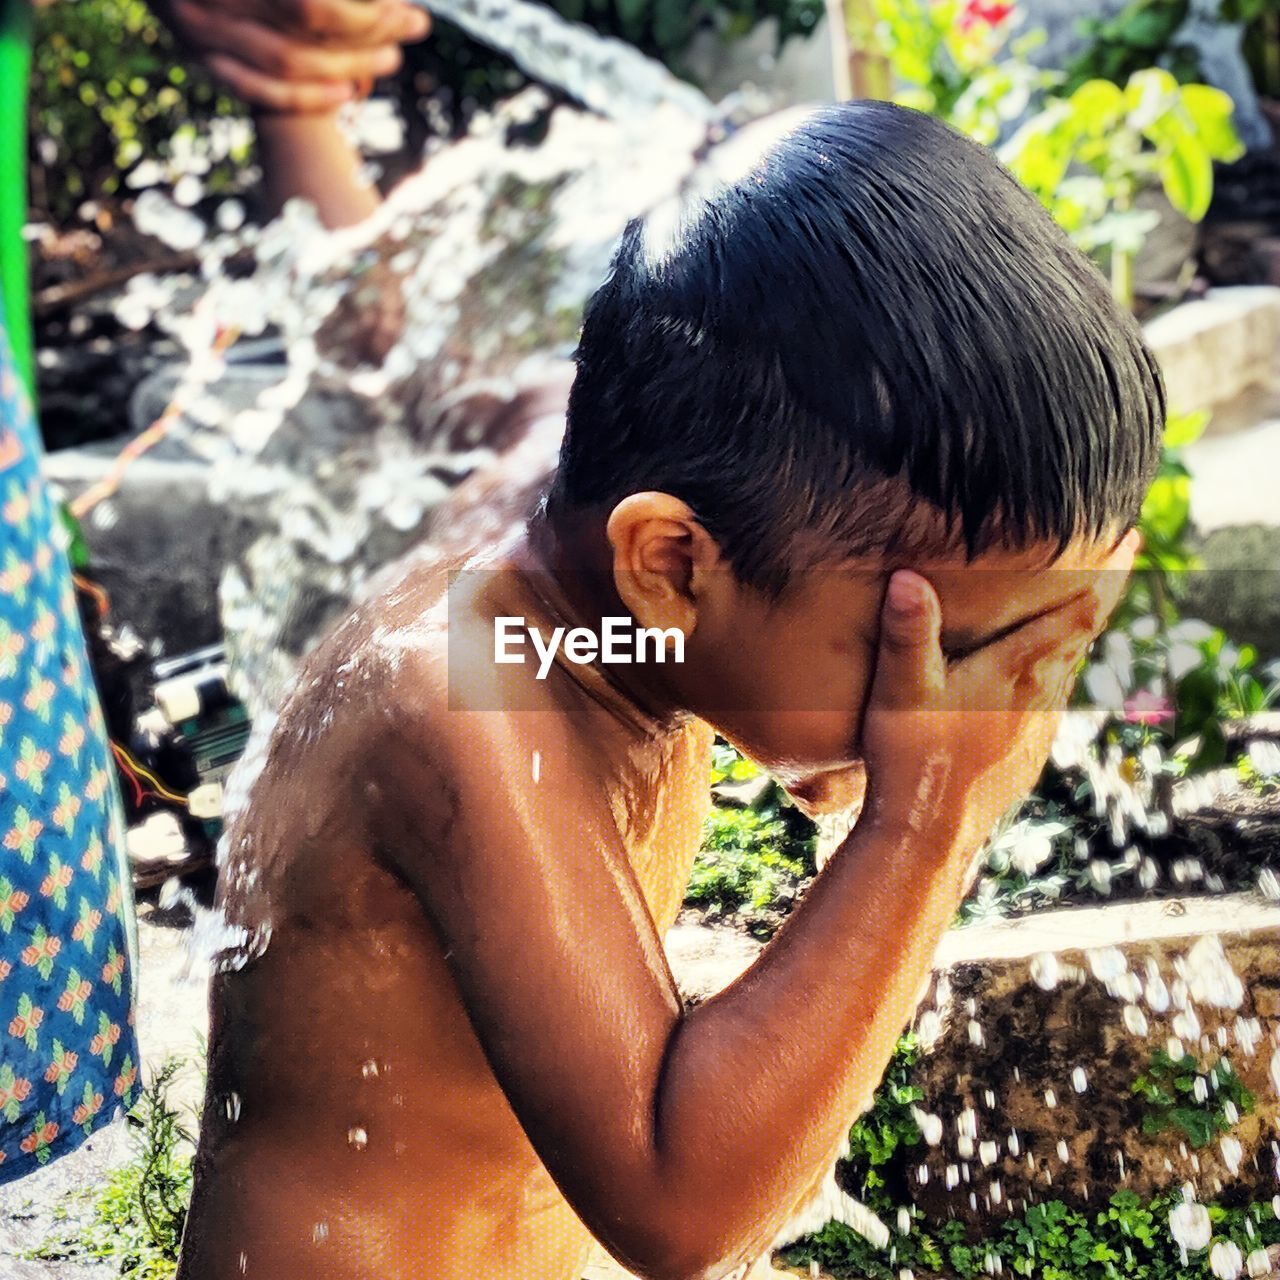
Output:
(0, 304), (138, 1183)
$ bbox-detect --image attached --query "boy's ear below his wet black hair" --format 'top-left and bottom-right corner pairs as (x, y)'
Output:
(604, 490), (726, 639)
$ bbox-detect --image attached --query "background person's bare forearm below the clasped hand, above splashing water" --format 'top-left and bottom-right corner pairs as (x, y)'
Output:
(255, 111), (381, 228)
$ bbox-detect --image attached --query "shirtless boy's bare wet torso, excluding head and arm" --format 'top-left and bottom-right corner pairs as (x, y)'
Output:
(180, 555), (710, 1280)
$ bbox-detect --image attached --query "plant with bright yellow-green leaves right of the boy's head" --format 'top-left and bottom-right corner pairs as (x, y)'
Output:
(1000, 68), (1244, 307)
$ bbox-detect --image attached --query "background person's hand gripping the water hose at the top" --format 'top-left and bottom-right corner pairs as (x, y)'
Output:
(157, 0), (431, 114)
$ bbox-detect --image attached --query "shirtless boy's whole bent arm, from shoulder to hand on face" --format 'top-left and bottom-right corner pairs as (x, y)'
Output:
(384, 555), (1123, 1280)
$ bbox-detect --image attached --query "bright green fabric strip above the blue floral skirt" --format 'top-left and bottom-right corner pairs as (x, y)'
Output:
(0, 0), (35, 398)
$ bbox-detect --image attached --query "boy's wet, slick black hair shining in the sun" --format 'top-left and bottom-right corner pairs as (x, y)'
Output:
(545, 102), (1165, 594)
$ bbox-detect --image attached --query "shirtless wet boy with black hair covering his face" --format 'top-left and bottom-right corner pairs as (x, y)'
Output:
(180, 102), (1164, 1280)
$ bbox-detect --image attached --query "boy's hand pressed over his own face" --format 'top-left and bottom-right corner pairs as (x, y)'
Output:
(863, 535), (1138, 852)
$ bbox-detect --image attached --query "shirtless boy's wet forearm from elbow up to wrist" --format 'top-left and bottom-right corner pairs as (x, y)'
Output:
(654, 803), (973, 1276)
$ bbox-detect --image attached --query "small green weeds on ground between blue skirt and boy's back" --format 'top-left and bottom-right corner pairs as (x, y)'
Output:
(31, 1059), (196, 1280)
